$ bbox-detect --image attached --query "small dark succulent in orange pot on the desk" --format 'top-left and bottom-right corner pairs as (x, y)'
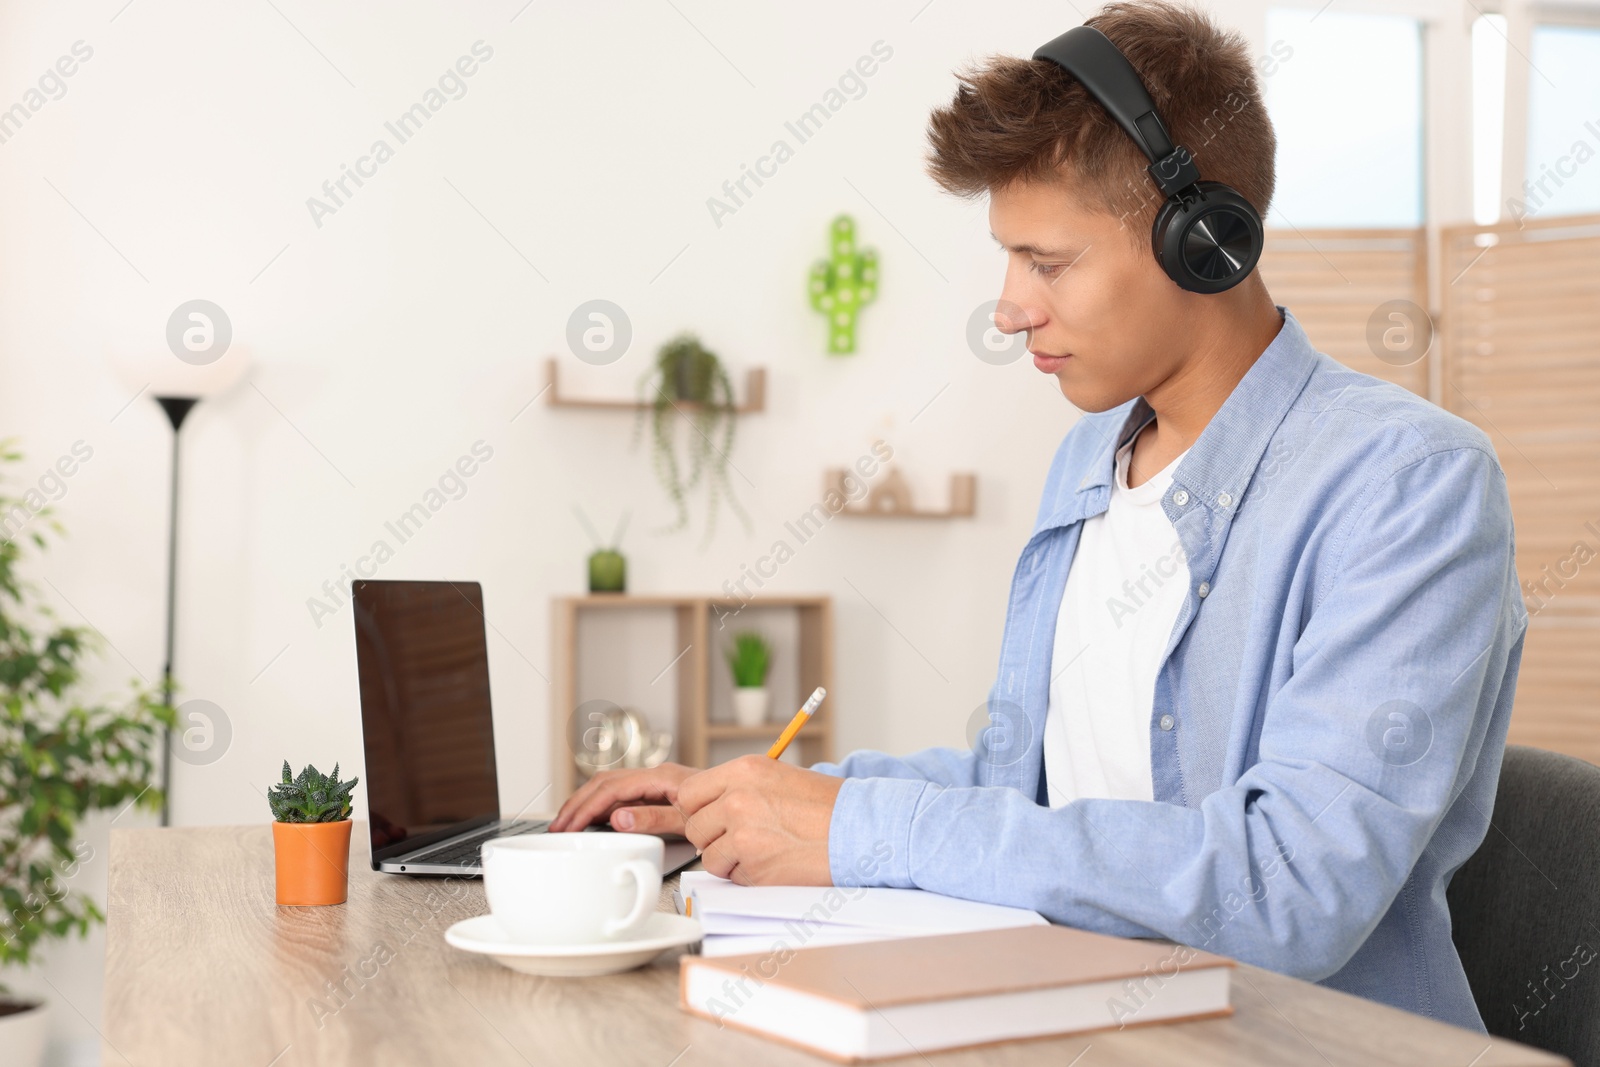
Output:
(267, 760), (358, 905)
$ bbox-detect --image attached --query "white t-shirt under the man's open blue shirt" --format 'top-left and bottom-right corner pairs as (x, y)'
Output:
(1045, 443), (1189, 808)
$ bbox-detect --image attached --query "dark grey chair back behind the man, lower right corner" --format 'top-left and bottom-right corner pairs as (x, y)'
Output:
(1448, 745), (1600, 1067)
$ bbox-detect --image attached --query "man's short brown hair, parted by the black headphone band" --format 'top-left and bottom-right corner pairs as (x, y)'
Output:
(928, 0), (1277, 242)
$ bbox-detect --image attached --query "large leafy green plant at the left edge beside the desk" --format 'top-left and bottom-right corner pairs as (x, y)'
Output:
(0, 440), (174, 992)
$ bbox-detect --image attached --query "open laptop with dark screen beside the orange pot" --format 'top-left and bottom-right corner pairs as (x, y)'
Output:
(352, 579), (696, 877)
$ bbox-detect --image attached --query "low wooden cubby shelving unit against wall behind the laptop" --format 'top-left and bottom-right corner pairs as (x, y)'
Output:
(550, 593), (838, 803)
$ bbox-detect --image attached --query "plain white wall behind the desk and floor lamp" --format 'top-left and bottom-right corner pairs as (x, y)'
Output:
(0, 0), (1286, 1049)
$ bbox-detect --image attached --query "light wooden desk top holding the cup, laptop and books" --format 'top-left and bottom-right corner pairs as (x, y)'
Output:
(102, 824), (1566, 1067)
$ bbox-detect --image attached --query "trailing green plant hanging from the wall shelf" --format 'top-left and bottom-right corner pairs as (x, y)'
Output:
(635, 333), (750, 547)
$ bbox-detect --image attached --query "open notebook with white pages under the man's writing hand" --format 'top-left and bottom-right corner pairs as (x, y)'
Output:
(675, 870), (1046, 957)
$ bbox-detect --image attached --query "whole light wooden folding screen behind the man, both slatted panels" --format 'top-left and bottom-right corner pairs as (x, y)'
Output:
(1261, 214), (1600, 763)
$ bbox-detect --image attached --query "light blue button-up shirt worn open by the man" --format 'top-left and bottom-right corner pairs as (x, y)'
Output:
(814, 309), (1528, 1030)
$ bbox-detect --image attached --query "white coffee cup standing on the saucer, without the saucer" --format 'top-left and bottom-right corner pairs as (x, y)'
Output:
(482, 832), (664, 945)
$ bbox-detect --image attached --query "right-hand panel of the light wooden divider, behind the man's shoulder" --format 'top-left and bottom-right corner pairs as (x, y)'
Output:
(1440, 216), (1600, 763)
